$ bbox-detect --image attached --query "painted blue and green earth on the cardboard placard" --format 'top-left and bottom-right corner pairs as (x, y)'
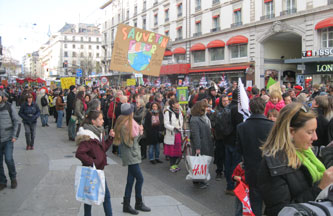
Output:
(128, 42), (152, 71)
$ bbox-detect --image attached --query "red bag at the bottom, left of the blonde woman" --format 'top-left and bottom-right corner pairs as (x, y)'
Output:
(234, 181), (255, 216)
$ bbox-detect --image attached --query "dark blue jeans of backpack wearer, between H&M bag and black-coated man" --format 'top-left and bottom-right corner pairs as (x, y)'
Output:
(224, 145), (242, 190)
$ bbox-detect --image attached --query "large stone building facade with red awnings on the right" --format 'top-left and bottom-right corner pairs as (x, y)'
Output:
(101, 0), (333, 88)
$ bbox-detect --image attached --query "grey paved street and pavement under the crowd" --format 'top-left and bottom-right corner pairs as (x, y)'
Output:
(0, 117), (234, 216)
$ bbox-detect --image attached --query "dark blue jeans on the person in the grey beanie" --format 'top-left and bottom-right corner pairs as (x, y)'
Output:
(125, 164), (143, 198)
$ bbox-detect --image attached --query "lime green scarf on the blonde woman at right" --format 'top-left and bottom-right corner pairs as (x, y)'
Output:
(296, 148), (326, 183)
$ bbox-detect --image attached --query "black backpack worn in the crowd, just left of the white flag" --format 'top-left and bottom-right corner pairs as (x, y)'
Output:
(214, 107), (233, 136)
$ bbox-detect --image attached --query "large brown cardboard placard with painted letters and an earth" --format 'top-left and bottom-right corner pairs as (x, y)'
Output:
(110, 24), (169, 76)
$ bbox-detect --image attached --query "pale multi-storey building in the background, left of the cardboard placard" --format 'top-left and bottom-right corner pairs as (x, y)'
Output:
(39, 23), (103, 78)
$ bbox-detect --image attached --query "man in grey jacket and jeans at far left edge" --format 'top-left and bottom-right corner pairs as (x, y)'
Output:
(0, 91), (19, 191)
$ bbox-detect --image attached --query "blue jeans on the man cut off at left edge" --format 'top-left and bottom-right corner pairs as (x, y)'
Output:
(0, 141), (16, 184)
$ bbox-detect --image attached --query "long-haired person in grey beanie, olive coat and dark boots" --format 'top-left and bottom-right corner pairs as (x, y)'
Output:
(111, 103), (150, 215)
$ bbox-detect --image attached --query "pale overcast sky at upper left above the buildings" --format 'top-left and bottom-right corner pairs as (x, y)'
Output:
(0, 0), (107, 62)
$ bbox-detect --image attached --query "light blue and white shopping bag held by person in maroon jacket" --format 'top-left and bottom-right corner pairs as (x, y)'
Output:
(75, 165), (105, 205)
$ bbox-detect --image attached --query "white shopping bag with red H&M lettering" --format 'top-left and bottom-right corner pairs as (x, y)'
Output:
(186, 155), (212, 181)
